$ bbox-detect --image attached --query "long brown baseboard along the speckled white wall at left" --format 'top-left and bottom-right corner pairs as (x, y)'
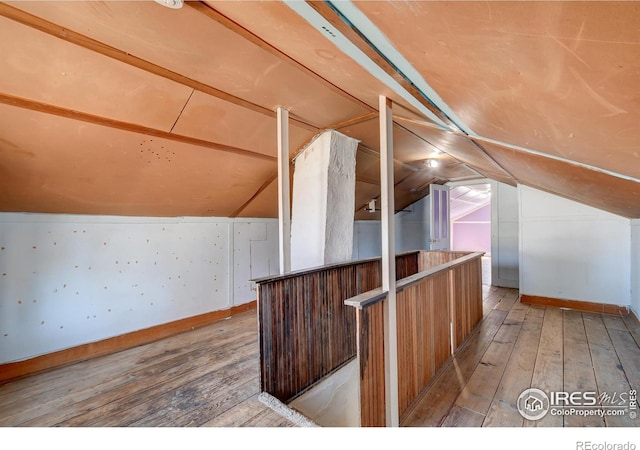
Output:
(0, 300), (256, 384)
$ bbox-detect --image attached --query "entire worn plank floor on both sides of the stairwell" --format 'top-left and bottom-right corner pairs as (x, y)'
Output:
(0, 287), (640, 427)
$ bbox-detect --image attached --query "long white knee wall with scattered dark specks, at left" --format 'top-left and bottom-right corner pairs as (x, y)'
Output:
(0, 213), (278, 363)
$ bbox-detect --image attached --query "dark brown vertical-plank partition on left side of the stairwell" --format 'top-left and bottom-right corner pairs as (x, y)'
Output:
(255, 252), (419, 402)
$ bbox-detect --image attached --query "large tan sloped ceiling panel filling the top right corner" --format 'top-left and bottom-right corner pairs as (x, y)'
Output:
(358, 2), (640, 178)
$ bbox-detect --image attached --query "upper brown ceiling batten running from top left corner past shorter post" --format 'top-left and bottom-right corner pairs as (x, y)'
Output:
(0, 2), (319, 131)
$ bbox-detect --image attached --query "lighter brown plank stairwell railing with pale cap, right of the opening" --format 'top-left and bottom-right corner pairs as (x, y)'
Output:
(345, 252), (482, 426)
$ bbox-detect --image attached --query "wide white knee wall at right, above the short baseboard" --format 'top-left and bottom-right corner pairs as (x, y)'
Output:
(518, 186), (631, 305)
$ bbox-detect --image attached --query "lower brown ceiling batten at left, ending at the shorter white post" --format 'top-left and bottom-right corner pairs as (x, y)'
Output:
(0, 93), (276, 163)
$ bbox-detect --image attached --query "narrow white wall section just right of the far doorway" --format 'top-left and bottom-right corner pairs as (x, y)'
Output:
(491, 181), (520, 288)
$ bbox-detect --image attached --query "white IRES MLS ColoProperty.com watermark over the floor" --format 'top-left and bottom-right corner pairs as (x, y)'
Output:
(516, 388), (638, 420)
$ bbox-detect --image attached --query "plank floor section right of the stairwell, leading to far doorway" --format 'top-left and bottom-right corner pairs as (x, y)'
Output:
(401, 287), (640, 427)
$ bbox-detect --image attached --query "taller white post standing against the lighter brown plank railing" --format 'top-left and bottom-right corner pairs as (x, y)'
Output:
(379, 95), (400, 427)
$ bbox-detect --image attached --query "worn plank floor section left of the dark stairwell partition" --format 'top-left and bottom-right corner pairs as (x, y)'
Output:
(0, 311), (293, 427)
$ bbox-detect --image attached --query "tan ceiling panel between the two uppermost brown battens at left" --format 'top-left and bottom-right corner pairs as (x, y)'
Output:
(12, 1), (368, 127)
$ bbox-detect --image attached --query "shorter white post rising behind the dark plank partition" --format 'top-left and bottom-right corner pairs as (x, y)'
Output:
(277, 106), (291, 274)
